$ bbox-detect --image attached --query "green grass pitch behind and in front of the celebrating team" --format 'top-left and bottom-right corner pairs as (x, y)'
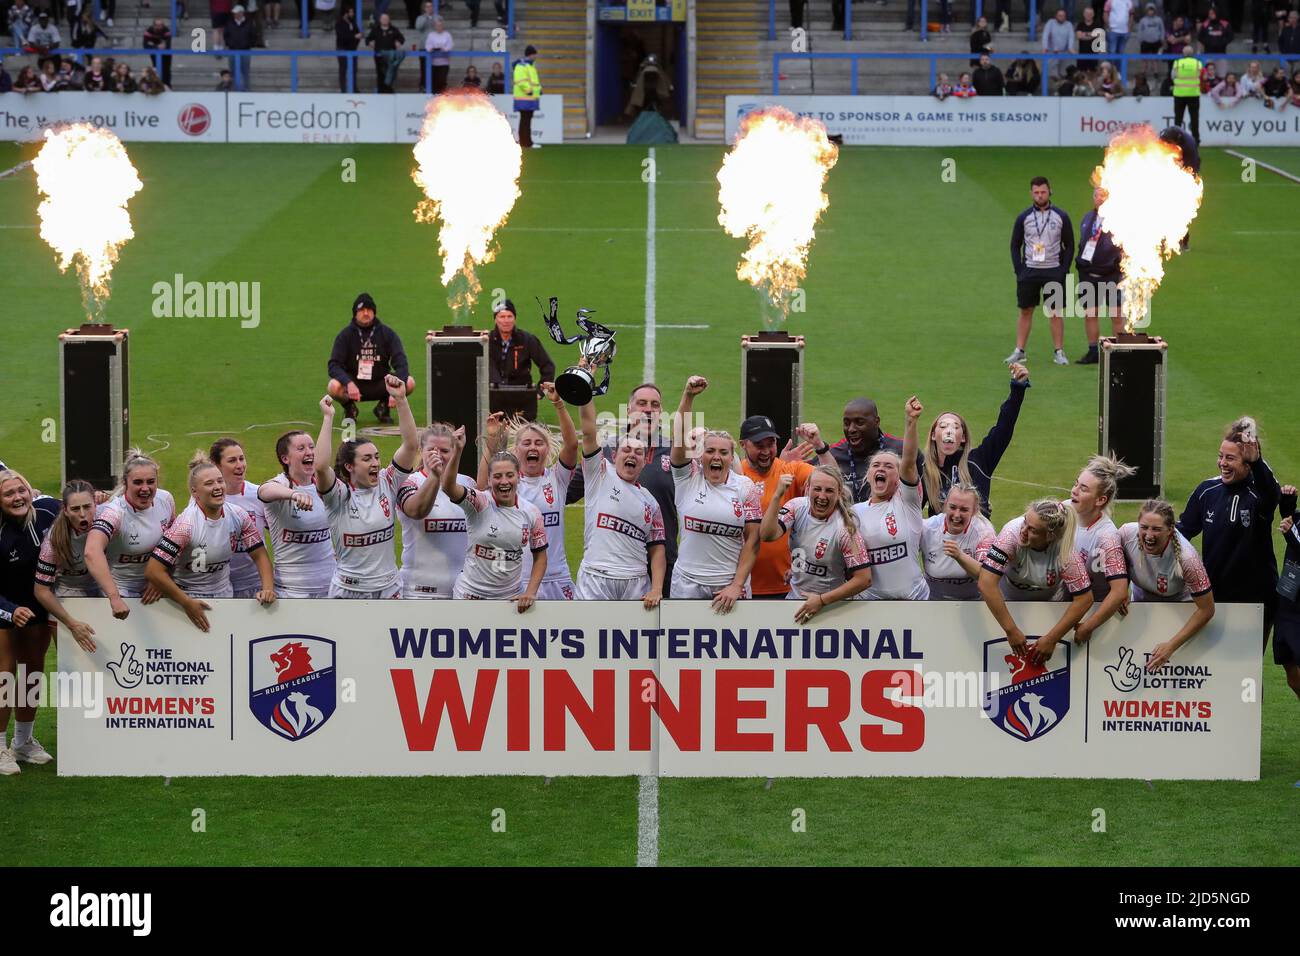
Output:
(0, 144), (1300, 865)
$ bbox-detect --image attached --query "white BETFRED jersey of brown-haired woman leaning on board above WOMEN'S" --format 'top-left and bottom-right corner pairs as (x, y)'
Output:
(459, 488), (546, 600)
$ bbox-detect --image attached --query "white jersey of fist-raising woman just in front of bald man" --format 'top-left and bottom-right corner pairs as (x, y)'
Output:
(853, 480), (930, 601)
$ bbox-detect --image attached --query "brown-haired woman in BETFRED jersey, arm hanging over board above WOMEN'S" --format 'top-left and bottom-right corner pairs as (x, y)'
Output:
(441, 434), (547, 614)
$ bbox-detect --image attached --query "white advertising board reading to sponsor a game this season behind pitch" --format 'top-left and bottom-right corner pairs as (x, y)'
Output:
(725, 95), (1300, 146)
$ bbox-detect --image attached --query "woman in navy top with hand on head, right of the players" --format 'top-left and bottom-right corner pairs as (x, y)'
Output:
(1178, 427), (1282, 646)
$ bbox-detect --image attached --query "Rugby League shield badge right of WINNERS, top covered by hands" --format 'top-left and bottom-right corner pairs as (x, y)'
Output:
(984, 637), (1070, 741)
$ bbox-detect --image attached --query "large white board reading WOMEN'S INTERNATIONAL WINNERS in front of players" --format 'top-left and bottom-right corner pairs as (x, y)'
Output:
(55, 600), (1262, 779)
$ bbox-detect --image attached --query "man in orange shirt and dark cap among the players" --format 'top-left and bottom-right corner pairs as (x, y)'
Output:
(740, 415), (836, 598)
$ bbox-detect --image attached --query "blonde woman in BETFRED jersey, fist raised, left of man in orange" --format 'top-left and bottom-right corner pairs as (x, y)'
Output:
(670, 375), (763, 614)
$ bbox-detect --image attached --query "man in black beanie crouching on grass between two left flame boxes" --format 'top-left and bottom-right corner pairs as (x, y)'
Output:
(329, 293), (415, 424)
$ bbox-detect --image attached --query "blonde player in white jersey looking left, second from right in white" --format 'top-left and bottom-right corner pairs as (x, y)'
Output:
(1070, 455), (1138, 644)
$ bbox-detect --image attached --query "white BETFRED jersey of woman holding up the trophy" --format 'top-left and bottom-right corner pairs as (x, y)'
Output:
(579, 451), (664, 579)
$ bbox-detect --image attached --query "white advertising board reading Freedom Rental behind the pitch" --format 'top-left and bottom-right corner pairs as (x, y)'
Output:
(0, 92), (564, 143)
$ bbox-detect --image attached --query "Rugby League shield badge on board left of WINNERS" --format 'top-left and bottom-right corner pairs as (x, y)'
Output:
(248, 633), (338, 740)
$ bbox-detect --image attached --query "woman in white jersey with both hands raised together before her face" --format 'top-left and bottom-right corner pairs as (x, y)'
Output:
(398, 421), (473, 601)
